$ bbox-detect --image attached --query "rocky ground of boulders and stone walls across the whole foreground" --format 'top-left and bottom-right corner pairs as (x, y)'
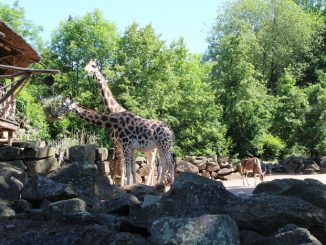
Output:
(0, 145), (326, 245)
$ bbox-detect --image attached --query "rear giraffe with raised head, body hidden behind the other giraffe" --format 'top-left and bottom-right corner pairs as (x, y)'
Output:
(84, 60), (157, 186)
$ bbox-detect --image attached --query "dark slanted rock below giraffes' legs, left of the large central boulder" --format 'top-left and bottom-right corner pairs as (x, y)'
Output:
(93, 194), (140, 216)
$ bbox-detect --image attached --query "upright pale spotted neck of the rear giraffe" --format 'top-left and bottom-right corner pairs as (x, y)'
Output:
(94, 71), (126, 113)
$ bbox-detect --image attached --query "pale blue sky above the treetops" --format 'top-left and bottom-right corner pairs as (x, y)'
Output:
(0, 0), (224, 53)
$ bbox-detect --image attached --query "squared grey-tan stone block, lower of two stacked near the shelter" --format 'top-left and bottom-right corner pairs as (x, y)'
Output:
(24, 157), (59, 177)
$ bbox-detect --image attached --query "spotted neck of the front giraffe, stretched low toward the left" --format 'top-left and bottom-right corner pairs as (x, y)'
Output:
(73, 104), (118, 129)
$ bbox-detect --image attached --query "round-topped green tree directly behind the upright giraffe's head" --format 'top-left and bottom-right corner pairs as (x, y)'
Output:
(43, 9), (118, 105)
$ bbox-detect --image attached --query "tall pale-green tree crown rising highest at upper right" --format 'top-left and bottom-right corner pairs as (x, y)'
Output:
(208, 0), (322, 91)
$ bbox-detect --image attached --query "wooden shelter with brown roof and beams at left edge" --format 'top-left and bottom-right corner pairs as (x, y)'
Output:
(0, 20), (59, 144)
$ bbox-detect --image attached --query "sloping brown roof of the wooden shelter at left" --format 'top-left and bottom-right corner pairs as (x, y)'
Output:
(0, 20), (41, 74)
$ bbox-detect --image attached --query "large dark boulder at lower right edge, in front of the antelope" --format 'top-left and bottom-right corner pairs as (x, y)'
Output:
(232, 193), (326, 243)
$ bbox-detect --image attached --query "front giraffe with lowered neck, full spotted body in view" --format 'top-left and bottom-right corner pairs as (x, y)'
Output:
(57, 98), (174, 185)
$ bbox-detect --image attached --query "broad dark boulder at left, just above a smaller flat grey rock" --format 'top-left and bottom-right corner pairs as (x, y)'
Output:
(22, 176), (78, 201)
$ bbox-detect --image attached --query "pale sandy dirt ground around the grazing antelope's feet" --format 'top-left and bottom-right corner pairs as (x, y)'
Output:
(222, 174), (326, 195)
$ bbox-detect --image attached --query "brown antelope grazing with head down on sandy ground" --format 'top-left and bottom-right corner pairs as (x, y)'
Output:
(240, 157), (265, 186)
